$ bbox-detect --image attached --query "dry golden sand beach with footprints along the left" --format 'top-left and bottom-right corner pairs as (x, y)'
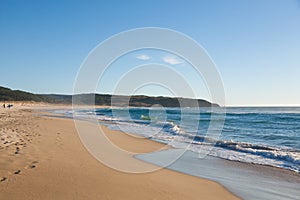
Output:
(0, 104), (238, 199)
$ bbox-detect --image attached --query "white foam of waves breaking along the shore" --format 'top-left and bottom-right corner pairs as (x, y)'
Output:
(51, 109), (300, 173)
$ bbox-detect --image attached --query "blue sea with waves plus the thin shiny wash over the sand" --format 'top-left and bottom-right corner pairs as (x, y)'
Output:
(52, 107), (300, 200)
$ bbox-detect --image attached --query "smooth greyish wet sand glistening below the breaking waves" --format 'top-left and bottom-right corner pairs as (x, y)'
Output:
(42, 105), (300, 199)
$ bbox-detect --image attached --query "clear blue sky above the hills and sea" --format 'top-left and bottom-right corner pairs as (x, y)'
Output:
(0, 0), (300, 106)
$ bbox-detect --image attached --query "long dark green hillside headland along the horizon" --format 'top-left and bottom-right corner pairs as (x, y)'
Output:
(0, 86), (218, 107)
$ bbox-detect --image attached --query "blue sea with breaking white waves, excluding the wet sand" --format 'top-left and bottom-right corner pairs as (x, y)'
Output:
(69, 107), (300, 173)
